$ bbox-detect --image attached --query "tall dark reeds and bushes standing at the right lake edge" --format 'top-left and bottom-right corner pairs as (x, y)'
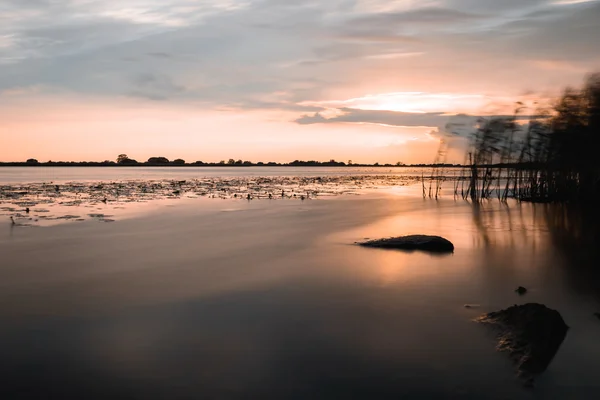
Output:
(462, 74), (600, 202)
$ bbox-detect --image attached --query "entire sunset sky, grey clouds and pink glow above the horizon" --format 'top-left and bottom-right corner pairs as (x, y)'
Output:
(0, 0), (600, 163)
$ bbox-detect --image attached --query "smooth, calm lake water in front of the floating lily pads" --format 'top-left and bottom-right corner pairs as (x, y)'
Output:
(0, 169), (600, 399)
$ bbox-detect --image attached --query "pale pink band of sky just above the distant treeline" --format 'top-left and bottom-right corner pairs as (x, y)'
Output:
(0, 95), (438, 163)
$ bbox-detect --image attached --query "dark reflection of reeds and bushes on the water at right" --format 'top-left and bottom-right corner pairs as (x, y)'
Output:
(471, 202), (600, 300)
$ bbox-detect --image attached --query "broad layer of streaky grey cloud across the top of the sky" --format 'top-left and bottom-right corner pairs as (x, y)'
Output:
(0, 0), (600, 112)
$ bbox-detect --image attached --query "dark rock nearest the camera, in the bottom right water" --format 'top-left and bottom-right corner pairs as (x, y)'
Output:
(478, 303), (569, 379)
